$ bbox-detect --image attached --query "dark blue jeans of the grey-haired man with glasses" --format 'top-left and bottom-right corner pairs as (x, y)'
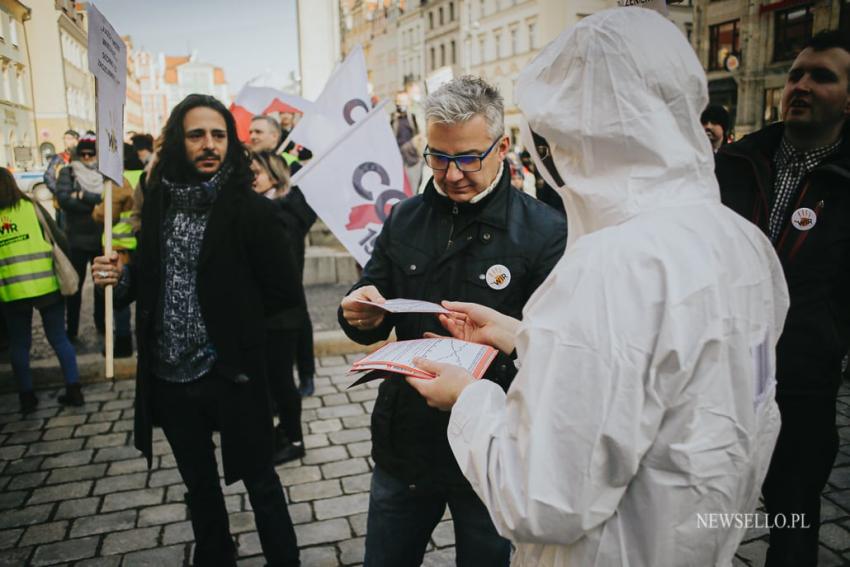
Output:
(363, 466), (511, 567)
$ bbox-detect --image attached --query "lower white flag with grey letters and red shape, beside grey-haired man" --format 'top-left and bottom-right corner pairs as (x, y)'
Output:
(292, 101), (413, 266)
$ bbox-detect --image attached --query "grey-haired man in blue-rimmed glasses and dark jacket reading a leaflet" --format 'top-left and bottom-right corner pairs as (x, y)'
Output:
(339, 77), (566, 567)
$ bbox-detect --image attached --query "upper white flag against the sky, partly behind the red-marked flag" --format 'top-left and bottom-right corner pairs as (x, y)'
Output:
(288, 45), (370, 155)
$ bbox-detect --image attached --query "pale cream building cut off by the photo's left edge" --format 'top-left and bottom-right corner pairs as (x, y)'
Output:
(0, 0), (36, 169)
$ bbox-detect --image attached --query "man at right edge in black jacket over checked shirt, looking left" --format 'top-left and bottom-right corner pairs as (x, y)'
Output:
(717, 32), (850, 567)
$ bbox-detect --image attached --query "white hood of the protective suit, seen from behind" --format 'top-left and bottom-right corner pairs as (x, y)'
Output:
(516, 8), (720, 246)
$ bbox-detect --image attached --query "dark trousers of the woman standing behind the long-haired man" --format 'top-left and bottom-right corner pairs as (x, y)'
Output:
(266, 329), (304, 442)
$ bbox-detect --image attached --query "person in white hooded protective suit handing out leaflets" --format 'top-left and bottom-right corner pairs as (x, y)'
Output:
(407, 8), (788, 567)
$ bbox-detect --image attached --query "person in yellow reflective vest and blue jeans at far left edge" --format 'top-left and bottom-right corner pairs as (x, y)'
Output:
(0, 168), (84, 413)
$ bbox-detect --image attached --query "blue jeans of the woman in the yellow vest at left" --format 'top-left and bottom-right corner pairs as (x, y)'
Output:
(3, 301), (80, 392)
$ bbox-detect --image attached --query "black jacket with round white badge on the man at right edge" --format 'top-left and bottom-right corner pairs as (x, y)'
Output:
(717, 124), (850, 396)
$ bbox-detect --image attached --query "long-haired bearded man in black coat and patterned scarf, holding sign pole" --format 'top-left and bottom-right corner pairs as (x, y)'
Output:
(92, 95), (305, 566)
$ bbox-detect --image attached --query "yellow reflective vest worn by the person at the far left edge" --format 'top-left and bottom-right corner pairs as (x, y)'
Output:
(0, 199), (59, 302)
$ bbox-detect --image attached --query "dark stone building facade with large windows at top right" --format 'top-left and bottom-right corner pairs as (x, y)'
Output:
(693, 0), (850, 137)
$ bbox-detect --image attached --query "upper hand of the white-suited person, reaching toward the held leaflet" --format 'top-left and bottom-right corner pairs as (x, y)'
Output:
(425, 301), (519, 354)
